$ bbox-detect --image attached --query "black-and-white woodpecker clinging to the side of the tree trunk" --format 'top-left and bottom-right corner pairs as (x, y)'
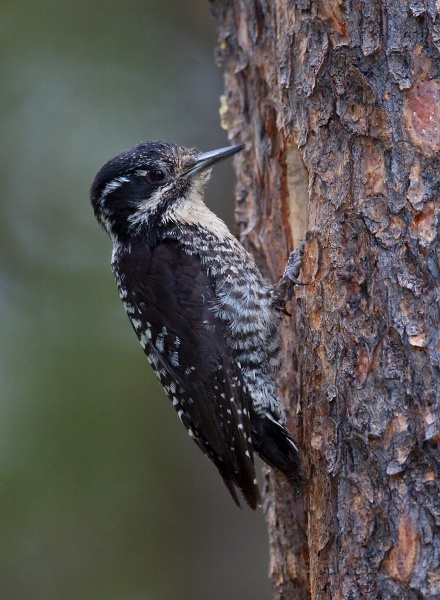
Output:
(90, 141), (303, 510)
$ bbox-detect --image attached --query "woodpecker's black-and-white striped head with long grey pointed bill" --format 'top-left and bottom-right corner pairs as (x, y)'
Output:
(90, 142), (244, 241)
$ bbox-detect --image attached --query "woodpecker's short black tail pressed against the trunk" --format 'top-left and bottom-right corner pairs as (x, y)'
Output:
(252, 412), (304, 490)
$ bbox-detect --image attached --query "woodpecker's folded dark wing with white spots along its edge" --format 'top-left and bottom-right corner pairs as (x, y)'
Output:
(117, 240), (261, 509)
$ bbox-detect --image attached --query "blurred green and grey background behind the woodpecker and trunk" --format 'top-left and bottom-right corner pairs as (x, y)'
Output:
(0, 0), (270, 600)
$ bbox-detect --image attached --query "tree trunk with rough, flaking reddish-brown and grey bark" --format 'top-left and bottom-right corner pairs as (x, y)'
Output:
(211, 0), (440, 600)
